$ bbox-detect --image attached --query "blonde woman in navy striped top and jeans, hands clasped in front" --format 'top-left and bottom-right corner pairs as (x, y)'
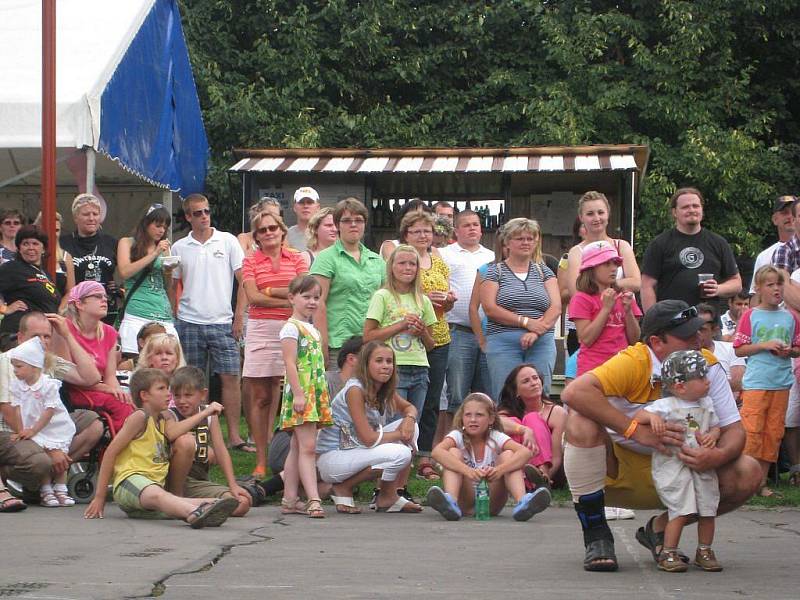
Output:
(480, 218), (561, 398)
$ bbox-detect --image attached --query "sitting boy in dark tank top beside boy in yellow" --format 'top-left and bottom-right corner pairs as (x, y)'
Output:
(167, 366), (251, 517)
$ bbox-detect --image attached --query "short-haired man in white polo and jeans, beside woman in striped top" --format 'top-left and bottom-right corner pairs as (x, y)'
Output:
(439, 210), (494, 415)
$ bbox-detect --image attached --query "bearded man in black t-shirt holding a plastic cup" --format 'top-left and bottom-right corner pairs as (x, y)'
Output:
(642, 188), (742, 311)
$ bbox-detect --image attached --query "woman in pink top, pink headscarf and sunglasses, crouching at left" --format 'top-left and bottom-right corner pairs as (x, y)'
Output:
(66, 281), (134, 432)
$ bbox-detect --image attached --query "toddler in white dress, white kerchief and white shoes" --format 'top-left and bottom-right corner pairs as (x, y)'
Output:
(8, 337), (75, 507)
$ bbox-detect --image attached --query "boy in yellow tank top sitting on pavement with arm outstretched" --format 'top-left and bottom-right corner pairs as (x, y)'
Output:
(84, 369), (239, 529)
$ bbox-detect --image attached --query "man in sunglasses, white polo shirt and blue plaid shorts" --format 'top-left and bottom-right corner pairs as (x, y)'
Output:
(172, 194), (246, 449)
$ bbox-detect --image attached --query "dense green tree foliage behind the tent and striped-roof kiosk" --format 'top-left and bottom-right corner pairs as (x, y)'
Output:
(181, 0), (800, 254)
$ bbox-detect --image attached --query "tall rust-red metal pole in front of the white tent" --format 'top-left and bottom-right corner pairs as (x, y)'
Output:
(42, 0), (56, 281)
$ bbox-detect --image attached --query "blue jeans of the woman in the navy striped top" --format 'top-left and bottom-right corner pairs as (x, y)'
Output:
(486, 329), (556, 402)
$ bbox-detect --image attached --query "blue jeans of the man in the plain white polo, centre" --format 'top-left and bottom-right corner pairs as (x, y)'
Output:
(447, 325), (491, 413)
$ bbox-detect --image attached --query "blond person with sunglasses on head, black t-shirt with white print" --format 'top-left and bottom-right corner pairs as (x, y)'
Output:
(60, 194), (119, 325)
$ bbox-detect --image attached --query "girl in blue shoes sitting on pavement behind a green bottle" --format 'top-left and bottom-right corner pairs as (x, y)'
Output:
(428, 393), (550, 521)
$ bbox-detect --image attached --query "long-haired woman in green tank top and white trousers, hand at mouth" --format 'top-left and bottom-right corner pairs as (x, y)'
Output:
(117, 204), (178, 356)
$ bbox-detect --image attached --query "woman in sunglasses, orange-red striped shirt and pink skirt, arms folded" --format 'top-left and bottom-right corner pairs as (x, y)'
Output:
(242, 212), (308, 478)
